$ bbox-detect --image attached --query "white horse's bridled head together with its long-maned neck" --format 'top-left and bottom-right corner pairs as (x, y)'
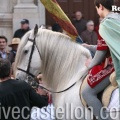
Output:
(15, 26), (91, 90)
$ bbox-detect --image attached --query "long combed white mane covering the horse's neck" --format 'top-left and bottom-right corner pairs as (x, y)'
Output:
(36, 29), (91, 91)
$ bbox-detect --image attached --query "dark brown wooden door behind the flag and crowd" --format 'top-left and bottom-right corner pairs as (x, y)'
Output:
(46, 0), (120, 25)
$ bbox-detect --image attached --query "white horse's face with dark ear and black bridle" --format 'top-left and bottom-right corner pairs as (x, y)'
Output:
(15, 25), (41, 81)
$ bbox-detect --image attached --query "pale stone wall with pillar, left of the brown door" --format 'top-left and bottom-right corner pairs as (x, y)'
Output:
(0, 0), (45, 44)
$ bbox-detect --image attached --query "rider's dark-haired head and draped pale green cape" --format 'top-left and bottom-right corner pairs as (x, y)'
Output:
(95, 0), (120, 94)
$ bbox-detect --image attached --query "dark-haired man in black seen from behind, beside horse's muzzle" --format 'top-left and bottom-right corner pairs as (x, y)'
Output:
(0, 58), (48, 120)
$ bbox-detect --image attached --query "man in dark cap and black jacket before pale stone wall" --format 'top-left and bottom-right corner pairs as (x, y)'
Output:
(13, 19), (30, 38)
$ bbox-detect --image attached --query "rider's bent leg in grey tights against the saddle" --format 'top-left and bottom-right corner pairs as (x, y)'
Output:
(82, 76), (110, 120)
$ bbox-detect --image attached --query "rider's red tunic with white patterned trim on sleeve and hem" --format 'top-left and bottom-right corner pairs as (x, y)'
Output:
(87, 39), (114, 88)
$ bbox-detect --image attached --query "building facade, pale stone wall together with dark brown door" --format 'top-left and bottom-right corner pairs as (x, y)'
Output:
(0, 0), (120, 42)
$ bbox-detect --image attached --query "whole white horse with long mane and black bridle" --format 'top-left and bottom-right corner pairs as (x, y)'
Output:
(15, 28), (119, 120)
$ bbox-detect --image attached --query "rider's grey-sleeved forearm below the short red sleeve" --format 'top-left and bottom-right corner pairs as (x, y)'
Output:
(88, 50), (107, 70)
